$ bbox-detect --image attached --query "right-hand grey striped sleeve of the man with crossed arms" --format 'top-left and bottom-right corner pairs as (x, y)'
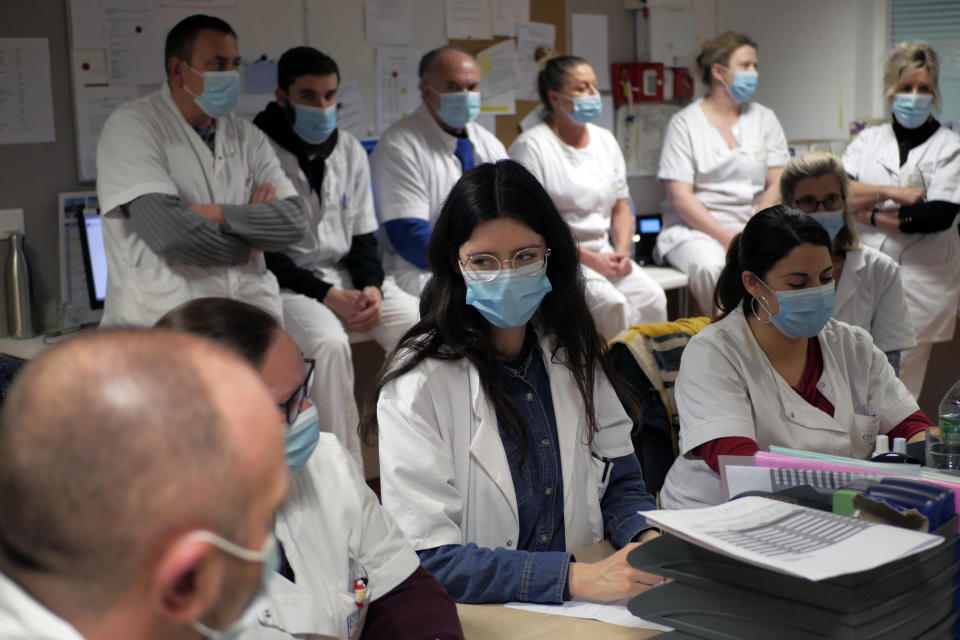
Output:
(220, 196), (307, 251)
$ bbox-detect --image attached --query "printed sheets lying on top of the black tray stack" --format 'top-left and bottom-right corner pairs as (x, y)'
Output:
(643, 496), (943, 580)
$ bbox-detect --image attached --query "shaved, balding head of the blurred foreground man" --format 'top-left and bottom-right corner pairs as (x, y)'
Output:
(0, 330), (283, 607)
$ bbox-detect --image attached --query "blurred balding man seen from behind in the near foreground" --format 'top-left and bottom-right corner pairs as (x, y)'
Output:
(0, 330), (289, 640)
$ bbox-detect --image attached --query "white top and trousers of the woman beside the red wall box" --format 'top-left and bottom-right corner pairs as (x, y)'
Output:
(654, 98), (790, 315)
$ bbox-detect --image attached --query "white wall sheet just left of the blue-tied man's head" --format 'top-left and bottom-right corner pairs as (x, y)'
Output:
(376, 47), (422, 132)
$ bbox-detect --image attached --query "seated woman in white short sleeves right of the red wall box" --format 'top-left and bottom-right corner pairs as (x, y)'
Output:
(654, 31), (790, 315)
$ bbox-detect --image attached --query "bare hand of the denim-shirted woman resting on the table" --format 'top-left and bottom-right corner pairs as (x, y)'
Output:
(570, 534), (663, 602)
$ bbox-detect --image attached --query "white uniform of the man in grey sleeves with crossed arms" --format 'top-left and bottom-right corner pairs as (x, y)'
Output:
(97, 84), (297, 326)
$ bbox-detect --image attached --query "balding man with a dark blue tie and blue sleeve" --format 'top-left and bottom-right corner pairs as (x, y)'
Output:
(370, 46), (507, 296)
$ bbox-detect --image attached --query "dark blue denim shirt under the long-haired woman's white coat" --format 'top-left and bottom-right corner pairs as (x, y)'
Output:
(417, 327), (656, 603)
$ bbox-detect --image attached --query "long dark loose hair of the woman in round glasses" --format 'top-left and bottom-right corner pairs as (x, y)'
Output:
(360, 160), (639, 451)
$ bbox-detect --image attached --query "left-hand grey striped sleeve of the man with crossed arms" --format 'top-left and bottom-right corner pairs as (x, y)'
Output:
(120, 193), (253, 267)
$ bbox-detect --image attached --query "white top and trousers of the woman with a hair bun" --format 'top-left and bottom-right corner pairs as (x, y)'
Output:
(510, 122), (667, 339)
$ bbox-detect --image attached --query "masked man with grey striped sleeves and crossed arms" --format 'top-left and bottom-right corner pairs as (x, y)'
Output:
(97, 15), (306, 325)
